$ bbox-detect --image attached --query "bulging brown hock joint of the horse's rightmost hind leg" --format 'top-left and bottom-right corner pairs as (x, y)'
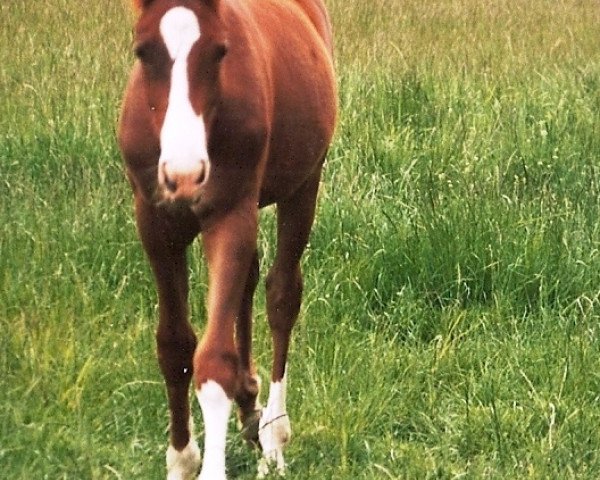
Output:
(265, 266), (302, 331)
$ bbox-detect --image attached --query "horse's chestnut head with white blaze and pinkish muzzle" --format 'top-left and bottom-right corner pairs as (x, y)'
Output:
(134, 0), (227, 203)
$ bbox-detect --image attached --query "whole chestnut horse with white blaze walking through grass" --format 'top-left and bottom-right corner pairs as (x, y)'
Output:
(119, 0), (336, 480)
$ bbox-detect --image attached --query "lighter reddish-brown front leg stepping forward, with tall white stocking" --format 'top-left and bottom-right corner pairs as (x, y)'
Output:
(194, 202), (258, 480)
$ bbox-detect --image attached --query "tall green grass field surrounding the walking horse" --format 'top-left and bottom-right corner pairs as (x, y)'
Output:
(0, 0), (600, 480)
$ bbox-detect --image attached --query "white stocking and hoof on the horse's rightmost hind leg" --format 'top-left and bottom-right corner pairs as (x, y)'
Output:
(258, 373), (292, 478)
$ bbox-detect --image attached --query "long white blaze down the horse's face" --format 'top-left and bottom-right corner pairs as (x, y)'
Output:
(159, 7), (208, 179)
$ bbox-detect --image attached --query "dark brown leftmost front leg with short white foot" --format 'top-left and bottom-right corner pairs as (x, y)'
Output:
(136, 199), (200, 480)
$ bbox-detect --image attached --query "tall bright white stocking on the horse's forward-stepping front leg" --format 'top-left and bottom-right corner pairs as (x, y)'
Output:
(196, 380), (231, 480)
